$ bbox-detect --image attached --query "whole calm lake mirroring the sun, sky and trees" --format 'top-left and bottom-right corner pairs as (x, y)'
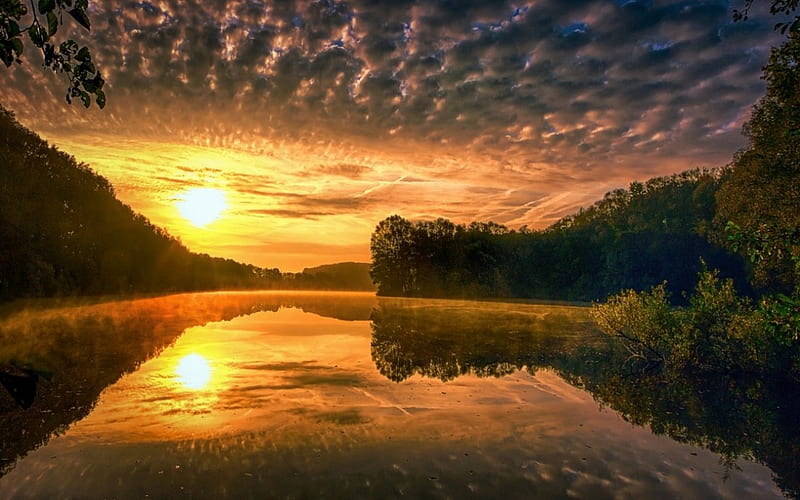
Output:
(0, 292), (800, 499)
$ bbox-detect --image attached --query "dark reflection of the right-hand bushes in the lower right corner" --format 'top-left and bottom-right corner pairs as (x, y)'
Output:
(560, 366), (800, 498)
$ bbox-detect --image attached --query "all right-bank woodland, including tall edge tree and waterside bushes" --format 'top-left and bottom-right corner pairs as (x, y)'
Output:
(371, 30), (800, 378)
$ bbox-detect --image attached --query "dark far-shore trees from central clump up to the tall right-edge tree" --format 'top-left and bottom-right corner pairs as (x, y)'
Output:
(371, 170), (744, 300)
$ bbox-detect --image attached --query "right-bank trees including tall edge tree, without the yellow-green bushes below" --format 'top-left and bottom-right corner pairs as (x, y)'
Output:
(370, 31), (800, 313)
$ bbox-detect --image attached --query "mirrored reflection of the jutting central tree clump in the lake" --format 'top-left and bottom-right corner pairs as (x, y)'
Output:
(371, 300), (604, 382)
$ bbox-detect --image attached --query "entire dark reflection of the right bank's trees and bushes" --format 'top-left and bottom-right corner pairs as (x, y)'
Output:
(372, 301), (800, 498)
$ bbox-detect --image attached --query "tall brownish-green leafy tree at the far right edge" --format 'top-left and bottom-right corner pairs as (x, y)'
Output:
(717, 31), (800, 292)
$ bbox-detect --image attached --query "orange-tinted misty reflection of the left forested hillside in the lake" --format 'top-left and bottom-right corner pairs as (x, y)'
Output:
(0, 292), (375, 478)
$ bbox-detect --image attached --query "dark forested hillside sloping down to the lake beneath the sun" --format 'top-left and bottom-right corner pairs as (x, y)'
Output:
(0, 107), (371, 301)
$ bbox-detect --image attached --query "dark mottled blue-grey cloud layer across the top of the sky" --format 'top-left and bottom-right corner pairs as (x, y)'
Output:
(6, 0), (774, 163)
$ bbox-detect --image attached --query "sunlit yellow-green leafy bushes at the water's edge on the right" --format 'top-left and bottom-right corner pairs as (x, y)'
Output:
(592, 270), (800, 382)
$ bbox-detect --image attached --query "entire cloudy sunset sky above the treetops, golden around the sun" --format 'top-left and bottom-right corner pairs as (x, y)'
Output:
(0, 0), (782, 271)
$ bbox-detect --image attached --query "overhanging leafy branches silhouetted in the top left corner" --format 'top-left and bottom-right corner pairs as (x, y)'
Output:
(0, 0), (106, 108)
